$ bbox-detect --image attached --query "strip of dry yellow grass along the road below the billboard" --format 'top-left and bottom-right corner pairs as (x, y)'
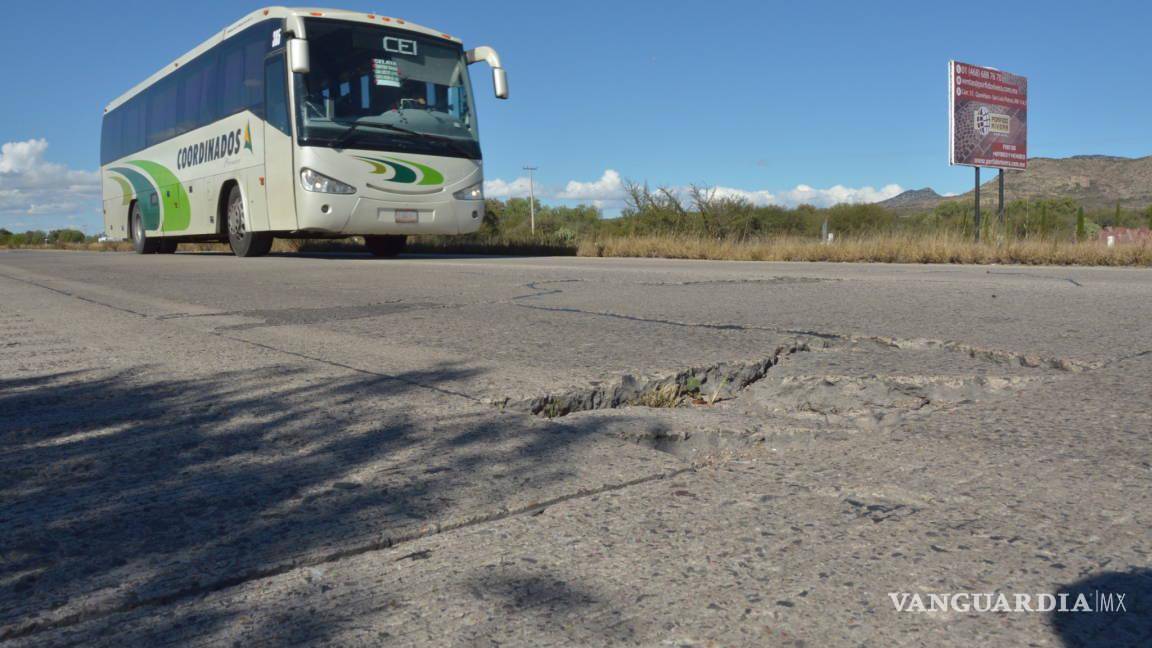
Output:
(578, 234), (1152, 266)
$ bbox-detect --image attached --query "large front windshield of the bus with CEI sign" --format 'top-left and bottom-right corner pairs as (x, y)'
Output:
(296, 20), (480, 159)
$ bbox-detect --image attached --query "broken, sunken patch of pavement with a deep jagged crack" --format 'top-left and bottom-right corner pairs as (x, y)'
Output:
(527, 340), (1052, 466)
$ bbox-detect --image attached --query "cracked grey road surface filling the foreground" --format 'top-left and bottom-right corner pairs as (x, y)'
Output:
(0, 251), (1152, 646)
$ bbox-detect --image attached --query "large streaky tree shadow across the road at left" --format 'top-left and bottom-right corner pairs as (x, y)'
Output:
(0, 367), (631, 643)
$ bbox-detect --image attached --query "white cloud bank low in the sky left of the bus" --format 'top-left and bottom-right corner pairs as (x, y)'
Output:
(0, 140), (100, 227)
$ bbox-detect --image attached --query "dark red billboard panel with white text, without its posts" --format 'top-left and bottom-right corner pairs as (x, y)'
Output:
(948, 61), (1028, 168)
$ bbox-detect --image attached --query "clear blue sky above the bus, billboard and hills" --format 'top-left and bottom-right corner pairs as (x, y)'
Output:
(0, 0), (1152, 232)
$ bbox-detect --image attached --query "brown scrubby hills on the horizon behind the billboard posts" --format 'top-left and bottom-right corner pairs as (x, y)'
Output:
(880, 156), (1152, 212)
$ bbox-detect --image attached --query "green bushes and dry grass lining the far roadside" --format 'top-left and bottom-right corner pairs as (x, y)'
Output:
(9, 178), (1152, 266)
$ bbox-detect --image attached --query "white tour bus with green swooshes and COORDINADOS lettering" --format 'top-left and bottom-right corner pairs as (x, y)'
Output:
(100, 7), (508, 257)
